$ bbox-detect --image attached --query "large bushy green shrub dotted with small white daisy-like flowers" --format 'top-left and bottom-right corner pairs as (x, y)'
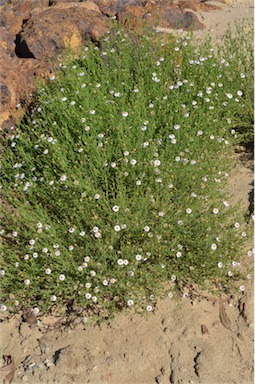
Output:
(1, 22), (252, 317)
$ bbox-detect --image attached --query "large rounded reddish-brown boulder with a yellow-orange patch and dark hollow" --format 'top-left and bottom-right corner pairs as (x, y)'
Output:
(16, 2), (108, 61)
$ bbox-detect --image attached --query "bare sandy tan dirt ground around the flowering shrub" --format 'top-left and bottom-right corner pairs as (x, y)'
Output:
(0, 0), (254, 384)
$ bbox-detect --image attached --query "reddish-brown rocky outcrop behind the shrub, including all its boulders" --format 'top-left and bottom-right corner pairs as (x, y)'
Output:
(0, 0), (220, 129)
